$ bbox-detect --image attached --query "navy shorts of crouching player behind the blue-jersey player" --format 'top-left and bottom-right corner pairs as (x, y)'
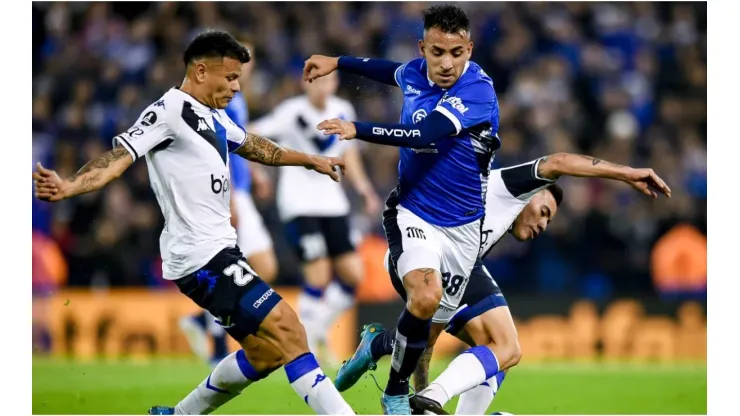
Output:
(388, 256), (508, 335)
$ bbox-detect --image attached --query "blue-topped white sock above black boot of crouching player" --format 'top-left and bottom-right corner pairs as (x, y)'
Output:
(421, 346), (498, 406)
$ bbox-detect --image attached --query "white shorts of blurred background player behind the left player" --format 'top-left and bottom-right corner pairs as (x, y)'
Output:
(232, 192), (272, 258)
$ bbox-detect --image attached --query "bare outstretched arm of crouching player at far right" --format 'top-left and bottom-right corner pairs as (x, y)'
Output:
(537, 153), (671, 198)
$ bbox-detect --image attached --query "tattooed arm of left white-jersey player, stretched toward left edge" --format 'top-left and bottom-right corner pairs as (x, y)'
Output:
(33, 145), (134, 202)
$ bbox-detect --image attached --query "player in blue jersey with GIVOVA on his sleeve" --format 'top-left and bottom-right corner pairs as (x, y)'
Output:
(304, 5), (500, 414)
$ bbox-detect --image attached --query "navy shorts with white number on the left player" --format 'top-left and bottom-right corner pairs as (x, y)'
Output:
(175, 247), (282, 341)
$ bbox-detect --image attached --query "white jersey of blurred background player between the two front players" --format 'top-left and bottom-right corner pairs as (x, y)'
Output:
(250, 95), (355, 221)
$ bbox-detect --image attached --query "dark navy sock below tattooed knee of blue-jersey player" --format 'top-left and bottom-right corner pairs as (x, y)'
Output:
(385, 309), (431, 396)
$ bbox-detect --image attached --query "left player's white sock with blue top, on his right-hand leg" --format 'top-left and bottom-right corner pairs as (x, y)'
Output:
(285, 353), (355, 415)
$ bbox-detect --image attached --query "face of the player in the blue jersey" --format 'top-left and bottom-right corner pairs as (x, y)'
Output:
(419, 27), (473, 88)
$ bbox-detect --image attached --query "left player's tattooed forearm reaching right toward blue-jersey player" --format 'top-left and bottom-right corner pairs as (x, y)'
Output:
(234, 133), (344, 182)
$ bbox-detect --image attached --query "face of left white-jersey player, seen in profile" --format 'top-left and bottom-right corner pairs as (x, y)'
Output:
(198, 57), (242, 108)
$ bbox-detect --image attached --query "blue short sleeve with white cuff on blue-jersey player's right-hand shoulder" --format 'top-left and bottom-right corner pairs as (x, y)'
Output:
(434, 81), (497, 134)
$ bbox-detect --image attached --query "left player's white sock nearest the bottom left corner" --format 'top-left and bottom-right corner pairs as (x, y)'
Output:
(175, 350), (261, 415)
